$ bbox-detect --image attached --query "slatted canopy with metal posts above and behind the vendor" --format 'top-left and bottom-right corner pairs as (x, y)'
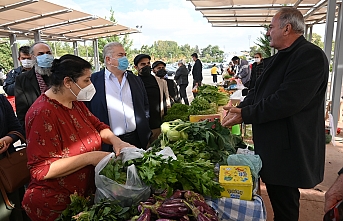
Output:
(186, 0), (343, 128)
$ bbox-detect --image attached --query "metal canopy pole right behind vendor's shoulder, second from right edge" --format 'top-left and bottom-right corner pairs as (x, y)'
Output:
(324, 0), (336, 100)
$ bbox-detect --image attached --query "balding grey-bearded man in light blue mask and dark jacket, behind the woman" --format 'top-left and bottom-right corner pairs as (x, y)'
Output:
(14, 42), (54, 128)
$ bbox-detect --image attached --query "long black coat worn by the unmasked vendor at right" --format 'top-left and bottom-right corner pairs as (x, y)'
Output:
(239, 36), (329, 188)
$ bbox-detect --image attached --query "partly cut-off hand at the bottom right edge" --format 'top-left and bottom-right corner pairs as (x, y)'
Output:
(324, 174), (343, 212)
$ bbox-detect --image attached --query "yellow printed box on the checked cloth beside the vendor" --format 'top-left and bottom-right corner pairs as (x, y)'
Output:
(219, 166), (253, 200)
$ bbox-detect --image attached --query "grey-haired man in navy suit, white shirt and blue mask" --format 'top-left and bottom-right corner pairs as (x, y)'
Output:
(86, 42), (151, 152)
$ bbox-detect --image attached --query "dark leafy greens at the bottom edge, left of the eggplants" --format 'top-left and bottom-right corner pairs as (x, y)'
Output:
(56, 192), (137, 221)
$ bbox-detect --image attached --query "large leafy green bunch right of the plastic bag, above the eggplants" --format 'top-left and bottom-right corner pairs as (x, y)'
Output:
(126, 151), (222, 198)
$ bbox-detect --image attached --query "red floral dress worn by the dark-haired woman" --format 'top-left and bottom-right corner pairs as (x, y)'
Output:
(22, 94), (109, 221)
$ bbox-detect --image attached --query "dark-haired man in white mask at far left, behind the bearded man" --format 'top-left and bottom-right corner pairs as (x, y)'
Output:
(4, 46), (33, 96)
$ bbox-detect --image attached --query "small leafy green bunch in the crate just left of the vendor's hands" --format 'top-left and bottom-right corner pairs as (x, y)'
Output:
(189, 96), (217, 115)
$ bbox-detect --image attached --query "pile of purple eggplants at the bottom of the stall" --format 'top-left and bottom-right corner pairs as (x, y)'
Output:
(131, 190), (218, 221)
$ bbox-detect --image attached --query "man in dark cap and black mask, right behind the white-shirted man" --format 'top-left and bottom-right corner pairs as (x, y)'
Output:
(133, 54), (163, 142)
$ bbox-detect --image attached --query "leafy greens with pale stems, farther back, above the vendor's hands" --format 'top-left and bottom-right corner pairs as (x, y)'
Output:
(198, 84), (229, 106)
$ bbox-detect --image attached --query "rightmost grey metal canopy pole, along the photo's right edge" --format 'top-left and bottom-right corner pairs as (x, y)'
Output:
(331, 2), (343, 128)
